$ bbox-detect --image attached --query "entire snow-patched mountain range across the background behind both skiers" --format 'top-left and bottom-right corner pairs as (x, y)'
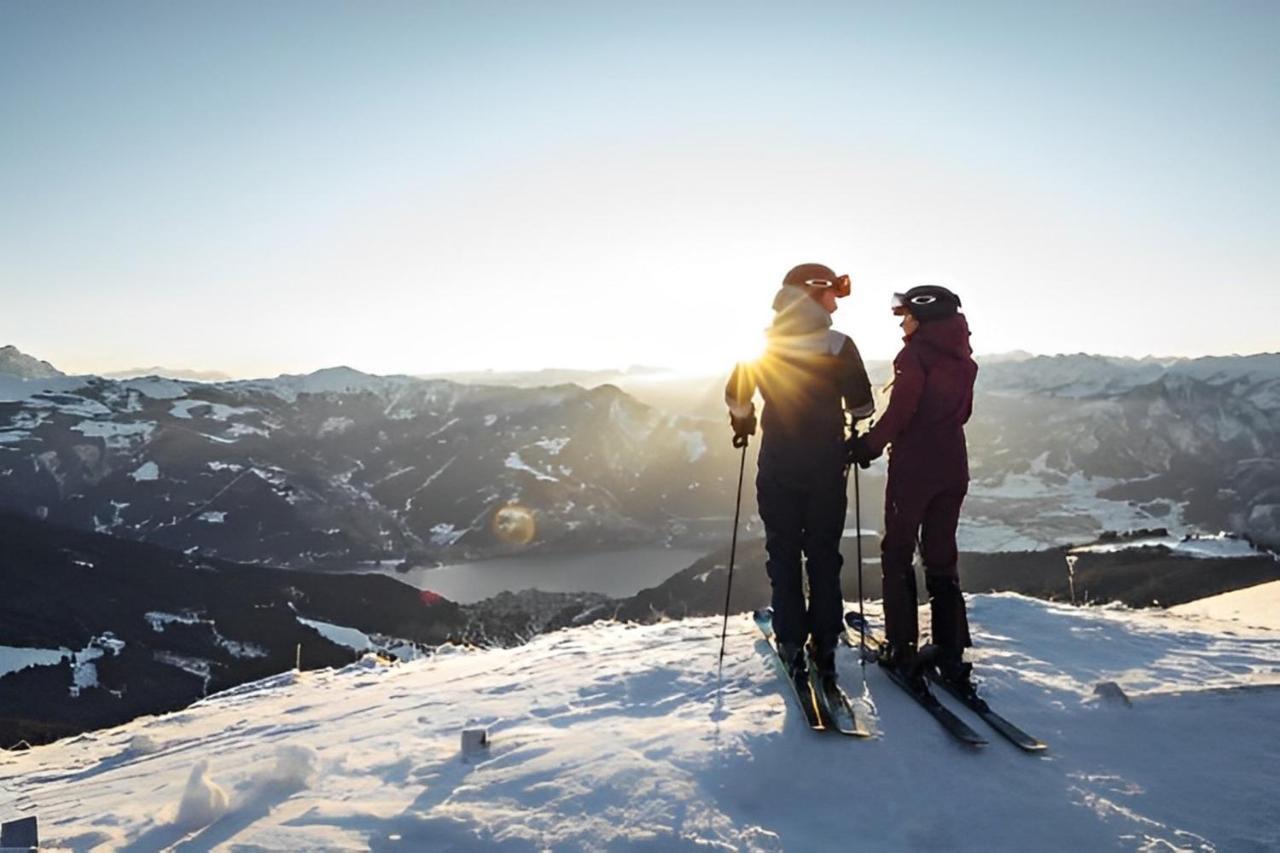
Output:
(0, 340), (1280, 567)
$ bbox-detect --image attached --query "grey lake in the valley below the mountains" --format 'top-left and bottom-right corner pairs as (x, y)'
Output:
(340, 547), (707, 605)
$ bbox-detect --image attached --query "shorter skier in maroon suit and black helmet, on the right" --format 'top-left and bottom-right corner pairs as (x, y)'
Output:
(849, 284), (978, 686)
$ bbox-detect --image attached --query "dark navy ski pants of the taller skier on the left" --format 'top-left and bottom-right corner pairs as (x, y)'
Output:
(755, 466), (847, 652)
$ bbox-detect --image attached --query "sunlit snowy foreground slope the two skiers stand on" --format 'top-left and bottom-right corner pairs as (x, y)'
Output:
(0, 594), (1280, 850)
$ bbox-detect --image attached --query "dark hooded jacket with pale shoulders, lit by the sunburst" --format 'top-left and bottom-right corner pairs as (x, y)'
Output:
(724, 287), (876, 479)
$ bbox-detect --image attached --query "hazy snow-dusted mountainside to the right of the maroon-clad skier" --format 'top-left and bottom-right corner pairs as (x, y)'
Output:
(965, 353), (1280, 546)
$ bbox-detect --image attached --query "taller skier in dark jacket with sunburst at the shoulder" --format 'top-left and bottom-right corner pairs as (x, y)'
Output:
(724, 264), (874, 678)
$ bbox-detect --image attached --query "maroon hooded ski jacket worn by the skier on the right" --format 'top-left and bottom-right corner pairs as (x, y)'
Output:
(867, 314), (978, 492)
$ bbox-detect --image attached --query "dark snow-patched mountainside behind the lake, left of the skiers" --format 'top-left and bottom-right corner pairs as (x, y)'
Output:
(0, 368), (732, 566)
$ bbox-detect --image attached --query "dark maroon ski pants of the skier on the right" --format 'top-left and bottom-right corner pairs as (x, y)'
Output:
(881, 476), (973, 649)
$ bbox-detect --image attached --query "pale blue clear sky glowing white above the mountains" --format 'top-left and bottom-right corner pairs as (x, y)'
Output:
(0, 0), (1280, 377)
